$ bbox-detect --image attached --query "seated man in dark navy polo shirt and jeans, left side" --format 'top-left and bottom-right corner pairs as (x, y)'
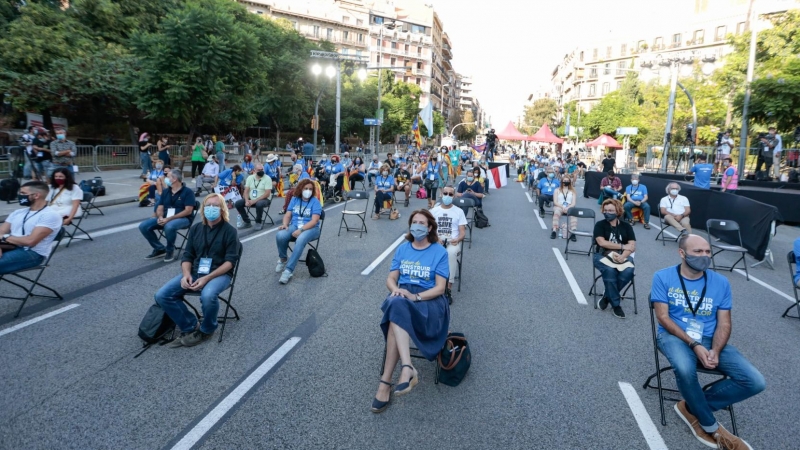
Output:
(139, 170), (195, 262)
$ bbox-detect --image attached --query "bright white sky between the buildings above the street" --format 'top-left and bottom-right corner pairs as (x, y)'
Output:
(431, 0), (694, 126)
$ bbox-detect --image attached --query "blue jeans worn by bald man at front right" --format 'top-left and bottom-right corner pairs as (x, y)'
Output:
(658, 331), (766, 433)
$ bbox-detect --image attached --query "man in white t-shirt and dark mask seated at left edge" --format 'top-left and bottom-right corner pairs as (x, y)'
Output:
(0, 181), (61, 274)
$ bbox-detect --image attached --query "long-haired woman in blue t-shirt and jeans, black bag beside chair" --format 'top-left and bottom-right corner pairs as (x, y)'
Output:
(275, 178), (322, 284)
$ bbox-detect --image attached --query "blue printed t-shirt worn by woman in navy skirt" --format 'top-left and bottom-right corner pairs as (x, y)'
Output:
(389, 242), (450, 290)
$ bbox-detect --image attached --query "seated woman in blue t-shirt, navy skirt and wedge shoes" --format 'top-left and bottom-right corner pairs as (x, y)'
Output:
(372, 209), (450, 413)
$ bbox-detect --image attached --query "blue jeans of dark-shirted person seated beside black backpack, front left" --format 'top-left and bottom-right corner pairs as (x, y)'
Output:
(156, 275), (231, 334)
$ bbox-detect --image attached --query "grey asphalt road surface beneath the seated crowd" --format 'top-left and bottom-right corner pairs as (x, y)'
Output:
(0, 176), (800, 449)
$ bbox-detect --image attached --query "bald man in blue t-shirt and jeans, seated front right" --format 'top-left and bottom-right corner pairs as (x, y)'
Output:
(650, 234), (766, 449)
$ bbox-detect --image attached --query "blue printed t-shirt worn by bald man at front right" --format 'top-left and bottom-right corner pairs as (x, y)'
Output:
(650, 266), (732, 337)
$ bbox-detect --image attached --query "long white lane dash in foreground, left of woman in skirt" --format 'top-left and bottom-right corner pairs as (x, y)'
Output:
(172, 337), (300, 450)
